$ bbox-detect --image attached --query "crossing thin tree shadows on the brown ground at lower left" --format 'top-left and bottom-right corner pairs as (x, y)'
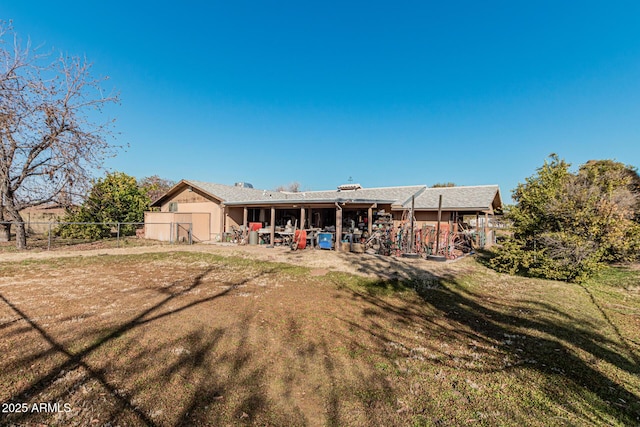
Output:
(0, 267), (280, 426)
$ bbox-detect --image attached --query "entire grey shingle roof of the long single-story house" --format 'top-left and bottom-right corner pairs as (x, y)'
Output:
(152, 180), (502, 211)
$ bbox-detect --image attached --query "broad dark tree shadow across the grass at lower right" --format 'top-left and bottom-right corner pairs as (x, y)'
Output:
(342, 261), (640, 425)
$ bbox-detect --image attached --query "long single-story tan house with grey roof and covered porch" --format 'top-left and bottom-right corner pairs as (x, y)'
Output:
(145, 180), (502, 251)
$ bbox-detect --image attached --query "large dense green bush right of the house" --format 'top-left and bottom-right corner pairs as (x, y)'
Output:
(491, 154), (640, 281)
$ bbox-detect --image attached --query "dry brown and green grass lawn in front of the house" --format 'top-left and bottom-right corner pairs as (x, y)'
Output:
(0, 248), (640, 426)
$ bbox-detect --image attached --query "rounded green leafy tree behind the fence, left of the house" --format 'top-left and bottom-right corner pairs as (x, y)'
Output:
(57, 172), (150, 239)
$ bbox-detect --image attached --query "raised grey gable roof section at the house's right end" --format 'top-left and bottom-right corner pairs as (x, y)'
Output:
(401, 185), (502, 213)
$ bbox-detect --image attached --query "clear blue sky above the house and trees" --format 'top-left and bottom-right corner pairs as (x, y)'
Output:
(0, 0), (640, 199)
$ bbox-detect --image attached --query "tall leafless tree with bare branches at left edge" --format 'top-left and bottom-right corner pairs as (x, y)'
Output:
(0, 22), (118, 249)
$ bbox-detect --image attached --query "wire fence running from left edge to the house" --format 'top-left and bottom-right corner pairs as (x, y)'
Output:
(0, 221), (193, 250)
